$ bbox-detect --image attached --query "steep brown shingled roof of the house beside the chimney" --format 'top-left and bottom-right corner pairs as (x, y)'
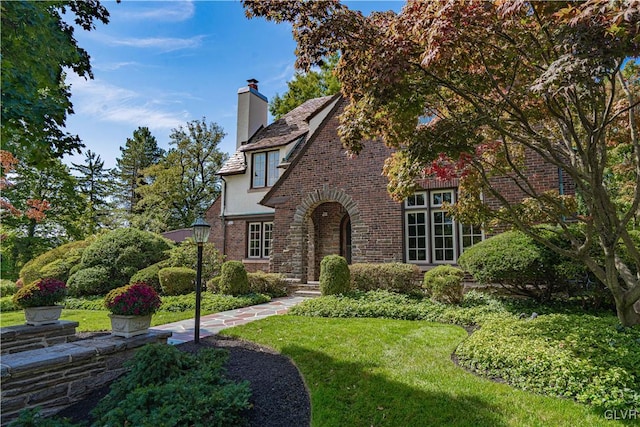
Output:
(217, 95), (337, 175)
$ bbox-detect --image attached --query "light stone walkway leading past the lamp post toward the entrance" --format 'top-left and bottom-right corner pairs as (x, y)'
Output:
(151, 296), (307, 344)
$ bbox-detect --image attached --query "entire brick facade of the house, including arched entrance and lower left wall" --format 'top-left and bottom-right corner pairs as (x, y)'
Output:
(206, 97), (575, 282)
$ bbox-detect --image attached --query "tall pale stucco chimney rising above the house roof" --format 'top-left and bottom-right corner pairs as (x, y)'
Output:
(236, 79), (269, 149)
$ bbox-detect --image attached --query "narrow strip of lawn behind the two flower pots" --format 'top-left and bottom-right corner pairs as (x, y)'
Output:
(0, 309), (204, 332)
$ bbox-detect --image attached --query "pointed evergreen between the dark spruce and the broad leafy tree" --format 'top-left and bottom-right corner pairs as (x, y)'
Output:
(114, 127), (165, 215)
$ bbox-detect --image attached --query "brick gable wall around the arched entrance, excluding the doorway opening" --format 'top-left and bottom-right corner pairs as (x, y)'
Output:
(262, 100), (403, 279)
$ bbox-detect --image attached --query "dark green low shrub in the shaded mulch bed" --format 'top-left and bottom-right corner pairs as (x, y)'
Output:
(93, 344), (251, 426)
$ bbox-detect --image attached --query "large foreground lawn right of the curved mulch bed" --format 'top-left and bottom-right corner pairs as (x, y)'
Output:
(222, 315), (622, 427)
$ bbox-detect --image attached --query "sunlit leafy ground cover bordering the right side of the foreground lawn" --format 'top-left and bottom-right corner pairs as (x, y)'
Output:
(290, 291), (640, 418)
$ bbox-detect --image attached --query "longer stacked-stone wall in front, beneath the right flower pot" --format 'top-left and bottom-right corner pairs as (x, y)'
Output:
(0, 328), (171, 426)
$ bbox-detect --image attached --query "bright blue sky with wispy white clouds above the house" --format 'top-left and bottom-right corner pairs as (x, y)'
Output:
(65, 0), (403, 168)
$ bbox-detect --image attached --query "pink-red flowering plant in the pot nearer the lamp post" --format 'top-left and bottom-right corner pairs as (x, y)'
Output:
(104, 282), (161, 316)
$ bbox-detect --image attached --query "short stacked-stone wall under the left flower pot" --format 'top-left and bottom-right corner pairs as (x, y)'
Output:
(0, 320), (78, 355)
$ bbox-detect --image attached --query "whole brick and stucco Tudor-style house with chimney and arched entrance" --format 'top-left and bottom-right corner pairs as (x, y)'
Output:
(206, 80), (569, 282)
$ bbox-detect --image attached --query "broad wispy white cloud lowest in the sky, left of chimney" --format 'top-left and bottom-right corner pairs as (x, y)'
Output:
(67, 75), (189, 130)
